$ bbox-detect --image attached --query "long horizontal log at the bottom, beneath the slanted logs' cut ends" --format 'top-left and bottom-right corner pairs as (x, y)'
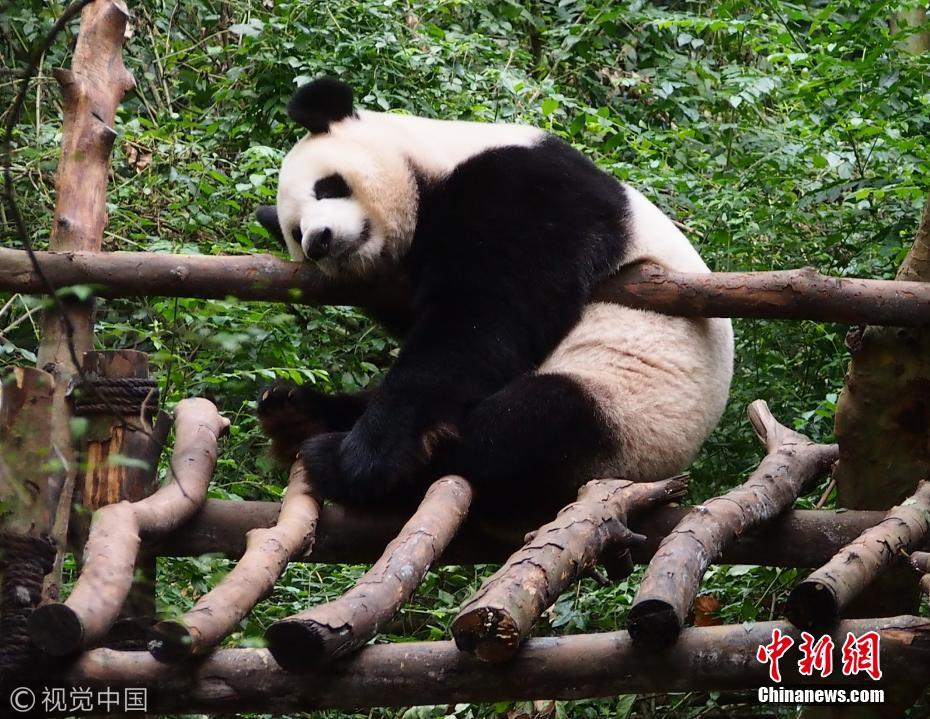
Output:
(63, 617), (930, 715)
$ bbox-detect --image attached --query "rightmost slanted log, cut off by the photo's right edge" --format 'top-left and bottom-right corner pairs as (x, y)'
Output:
(786, 482), (930, 631)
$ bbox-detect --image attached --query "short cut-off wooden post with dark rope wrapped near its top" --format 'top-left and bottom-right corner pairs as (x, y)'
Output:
(70, 350), (170, 639)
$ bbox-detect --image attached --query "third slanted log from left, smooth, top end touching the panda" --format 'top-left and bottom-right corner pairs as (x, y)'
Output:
(265, 476), (472, 671)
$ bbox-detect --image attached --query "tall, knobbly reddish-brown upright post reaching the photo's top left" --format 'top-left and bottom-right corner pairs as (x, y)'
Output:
(38, 0), (135, 599)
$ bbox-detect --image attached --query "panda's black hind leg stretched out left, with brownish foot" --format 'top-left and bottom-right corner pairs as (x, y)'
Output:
(258, 382), (369, 464)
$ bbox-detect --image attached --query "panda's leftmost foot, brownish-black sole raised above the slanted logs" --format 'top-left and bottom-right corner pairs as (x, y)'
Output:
(258, 382), (329, 463)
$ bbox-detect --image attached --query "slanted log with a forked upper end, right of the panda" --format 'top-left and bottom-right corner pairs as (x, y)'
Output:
(629, 400), (837, 649)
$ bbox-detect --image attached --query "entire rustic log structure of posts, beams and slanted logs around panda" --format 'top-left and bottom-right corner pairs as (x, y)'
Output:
(0, 0), (930, 713)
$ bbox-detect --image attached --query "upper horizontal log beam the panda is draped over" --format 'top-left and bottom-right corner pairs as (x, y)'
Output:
(0, 248), (930, 326)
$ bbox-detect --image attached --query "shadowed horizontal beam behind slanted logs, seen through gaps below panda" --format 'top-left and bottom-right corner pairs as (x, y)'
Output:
(147, 499), (885, 568)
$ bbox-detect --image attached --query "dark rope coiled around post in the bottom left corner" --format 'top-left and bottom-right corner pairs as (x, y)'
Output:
(0, 530), (55, 683)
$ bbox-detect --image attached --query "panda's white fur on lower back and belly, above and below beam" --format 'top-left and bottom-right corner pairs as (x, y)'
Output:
(538, 185), (733, 481)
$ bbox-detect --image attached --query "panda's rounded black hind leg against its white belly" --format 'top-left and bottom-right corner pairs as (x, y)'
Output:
(453, 373), (616, 521)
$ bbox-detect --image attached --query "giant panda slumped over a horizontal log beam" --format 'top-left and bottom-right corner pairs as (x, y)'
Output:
(258, 78), (733, 517)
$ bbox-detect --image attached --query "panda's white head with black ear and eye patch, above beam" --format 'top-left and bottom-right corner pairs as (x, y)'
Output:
(277, 78), (418, 276)
